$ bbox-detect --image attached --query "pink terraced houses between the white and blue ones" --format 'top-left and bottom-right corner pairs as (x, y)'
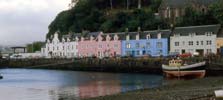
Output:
(77, 32), (121, 58)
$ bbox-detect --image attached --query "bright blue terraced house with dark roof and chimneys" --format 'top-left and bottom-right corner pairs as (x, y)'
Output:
(122, 30), (171, 57)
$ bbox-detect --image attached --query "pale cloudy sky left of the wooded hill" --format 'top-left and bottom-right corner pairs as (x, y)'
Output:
(0, 0), (71, 46)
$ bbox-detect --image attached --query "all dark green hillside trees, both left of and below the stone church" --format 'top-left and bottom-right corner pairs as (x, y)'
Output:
(47, 0), (223, 38)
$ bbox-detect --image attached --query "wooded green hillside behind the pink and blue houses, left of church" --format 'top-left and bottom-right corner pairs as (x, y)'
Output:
(47, 0), (167, 37)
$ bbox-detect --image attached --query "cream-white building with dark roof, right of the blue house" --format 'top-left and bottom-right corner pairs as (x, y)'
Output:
(170, 25), (220, 55)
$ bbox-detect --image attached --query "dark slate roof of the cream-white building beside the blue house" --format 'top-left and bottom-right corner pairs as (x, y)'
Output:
(173, 24), (221, 34)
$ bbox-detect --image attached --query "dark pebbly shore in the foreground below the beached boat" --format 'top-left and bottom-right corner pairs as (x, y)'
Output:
(85, 77), (223, 100)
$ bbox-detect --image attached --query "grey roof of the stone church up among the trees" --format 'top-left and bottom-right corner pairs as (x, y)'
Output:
(160, 0), (218, 8)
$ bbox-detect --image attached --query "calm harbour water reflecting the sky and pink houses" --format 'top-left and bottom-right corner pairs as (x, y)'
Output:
(0, 69), (163, 100)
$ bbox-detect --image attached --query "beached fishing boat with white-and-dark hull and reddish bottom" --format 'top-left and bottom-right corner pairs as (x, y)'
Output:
(162, 58), (206, 78)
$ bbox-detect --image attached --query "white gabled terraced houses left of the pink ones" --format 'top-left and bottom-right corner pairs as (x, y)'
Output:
(41, 33), (78, 58)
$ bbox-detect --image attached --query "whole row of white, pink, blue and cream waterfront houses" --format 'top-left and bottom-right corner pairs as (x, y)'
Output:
(41, 25), (221, 58)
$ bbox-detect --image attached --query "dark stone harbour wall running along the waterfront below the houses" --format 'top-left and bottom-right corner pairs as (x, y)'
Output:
(0, 58), (223, 76)
